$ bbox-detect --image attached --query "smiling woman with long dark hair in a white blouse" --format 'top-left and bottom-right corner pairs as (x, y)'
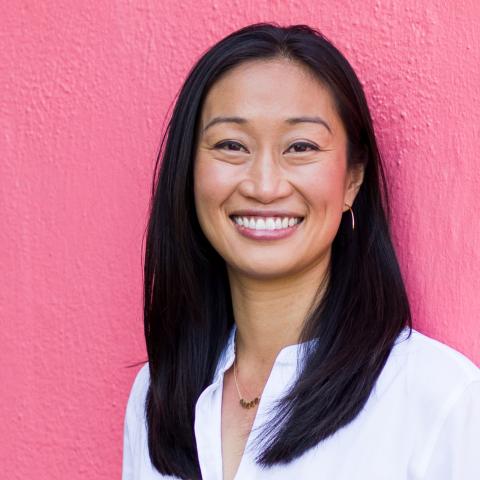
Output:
(123, 24), (480, 480)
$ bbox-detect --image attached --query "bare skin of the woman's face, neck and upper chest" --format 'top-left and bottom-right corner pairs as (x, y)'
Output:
(194, 58), (363, 479)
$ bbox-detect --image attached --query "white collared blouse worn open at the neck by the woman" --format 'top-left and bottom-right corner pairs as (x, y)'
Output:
(122, 329), (480, 480)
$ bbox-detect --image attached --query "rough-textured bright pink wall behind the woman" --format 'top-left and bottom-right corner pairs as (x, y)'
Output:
(0, 0), (480, 480)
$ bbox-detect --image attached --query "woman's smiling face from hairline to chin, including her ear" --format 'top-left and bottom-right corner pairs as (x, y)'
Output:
(194, 59), (362, 278)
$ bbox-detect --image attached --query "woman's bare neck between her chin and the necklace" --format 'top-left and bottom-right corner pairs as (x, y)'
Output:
(228, 253), (329, 371)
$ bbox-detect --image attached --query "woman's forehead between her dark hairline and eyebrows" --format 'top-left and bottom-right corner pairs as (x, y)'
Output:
(201, 58), (338, 124)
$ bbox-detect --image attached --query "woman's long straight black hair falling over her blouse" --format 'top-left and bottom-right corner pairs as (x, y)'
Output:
(144, 23), (412, 479)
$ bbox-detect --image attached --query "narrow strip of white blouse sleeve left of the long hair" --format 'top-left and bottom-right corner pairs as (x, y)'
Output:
(122, 363), (149, 480)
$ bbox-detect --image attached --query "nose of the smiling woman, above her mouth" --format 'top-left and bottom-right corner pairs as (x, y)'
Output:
(239, 149), (292, 203)
